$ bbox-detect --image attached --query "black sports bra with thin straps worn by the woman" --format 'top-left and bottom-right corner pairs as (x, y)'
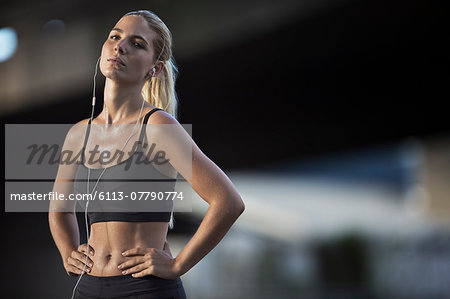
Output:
(74, 108), (176, 224)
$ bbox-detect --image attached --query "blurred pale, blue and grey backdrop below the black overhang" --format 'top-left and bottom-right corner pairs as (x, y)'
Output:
(172, 138), (450, 298)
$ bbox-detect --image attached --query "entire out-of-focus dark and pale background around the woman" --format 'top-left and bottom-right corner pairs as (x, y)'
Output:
(0, 0), (450, 299)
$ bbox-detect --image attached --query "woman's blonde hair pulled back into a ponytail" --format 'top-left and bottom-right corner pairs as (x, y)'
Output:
(124, 10), (178, 119)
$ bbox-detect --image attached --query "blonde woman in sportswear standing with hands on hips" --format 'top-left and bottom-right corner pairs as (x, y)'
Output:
(49, 11), (244, 298)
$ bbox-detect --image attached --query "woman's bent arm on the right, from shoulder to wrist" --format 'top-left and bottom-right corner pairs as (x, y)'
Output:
(147, 113), (245, 276)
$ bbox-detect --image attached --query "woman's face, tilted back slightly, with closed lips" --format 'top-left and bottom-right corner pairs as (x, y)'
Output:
(100, 16), (156, 83)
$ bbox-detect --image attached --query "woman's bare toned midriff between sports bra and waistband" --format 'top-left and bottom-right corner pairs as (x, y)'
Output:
(87, 221), (169, 277)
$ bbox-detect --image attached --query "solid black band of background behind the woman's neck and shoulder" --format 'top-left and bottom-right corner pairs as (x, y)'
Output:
(2, 0), (450, 169)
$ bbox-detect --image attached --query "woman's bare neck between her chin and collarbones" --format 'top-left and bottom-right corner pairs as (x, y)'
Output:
(101, 78), (144, 124)
